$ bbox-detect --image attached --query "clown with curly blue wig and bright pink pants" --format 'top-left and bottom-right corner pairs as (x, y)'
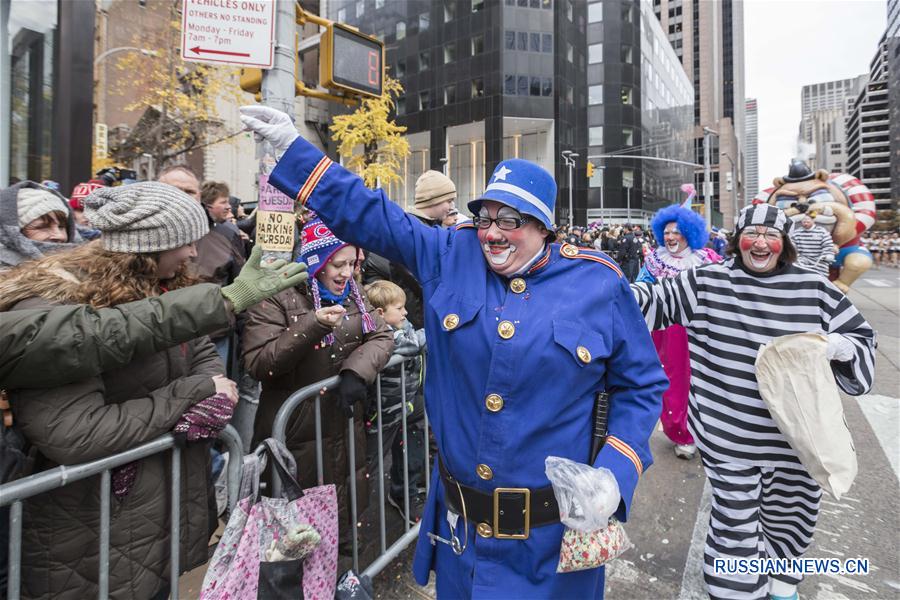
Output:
(637, 184), (722, 460)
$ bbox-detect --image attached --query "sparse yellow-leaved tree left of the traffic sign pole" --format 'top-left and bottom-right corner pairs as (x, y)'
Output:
(111, 0), (238, 172)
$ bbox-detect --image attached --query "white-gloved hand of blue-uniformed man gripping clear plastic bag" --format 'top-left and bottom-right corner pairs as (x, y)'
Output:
(544, 456), (621, 531)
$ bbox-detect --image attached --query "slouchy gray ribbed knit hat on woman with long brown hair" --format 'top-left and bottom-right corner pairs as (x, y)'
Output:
(84, 181), (209, 253)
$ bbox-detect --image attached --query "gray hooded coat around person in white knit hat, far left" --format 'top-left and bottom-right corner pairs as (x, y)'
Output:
(0, 181), (84, 271)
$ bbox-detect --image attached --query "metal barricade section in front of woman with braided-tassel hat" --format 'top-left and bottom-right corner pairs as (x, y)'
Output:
(272, 352), (431, 577)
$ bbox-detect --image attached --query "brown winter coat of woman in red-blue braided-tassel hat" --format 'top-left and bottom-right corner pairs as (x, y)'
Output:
(242, 285), (394, 530)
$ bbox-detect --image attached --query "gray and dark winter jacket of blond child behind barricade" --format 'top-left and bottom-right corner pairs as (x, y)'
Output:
(366, 321), (425, 431)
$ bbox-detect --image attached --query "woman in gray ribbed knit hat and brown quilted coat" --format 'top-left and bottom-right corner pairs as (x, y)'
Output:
(0, 183), (237, 599)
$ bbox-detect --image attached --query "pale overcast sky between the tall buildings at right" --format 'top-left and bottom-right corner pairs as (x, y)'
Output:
(744, 0), (887, 195)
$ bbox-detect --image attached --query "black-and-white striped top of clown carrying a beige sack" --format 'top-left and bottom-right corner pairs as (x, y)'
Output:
(631, 258), (875, 468)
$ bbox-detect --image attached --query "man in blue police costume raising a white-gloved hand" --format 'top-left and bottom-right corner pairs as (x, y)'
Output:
(241, 107), (667, 598)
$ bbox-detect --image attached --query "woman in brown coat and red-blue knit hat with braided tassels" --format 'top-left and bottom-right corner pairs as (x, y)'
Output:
(243, 219), (394, 538)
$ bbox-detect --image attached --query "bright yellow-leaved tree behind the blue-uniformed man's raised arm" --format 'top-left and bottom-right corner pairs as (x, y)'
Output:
(331, 74), (409, 188)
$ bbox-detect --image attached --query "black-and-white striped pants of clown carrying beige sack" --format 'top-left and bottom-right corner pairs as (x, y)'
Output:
(703, 460), (822, 599)
